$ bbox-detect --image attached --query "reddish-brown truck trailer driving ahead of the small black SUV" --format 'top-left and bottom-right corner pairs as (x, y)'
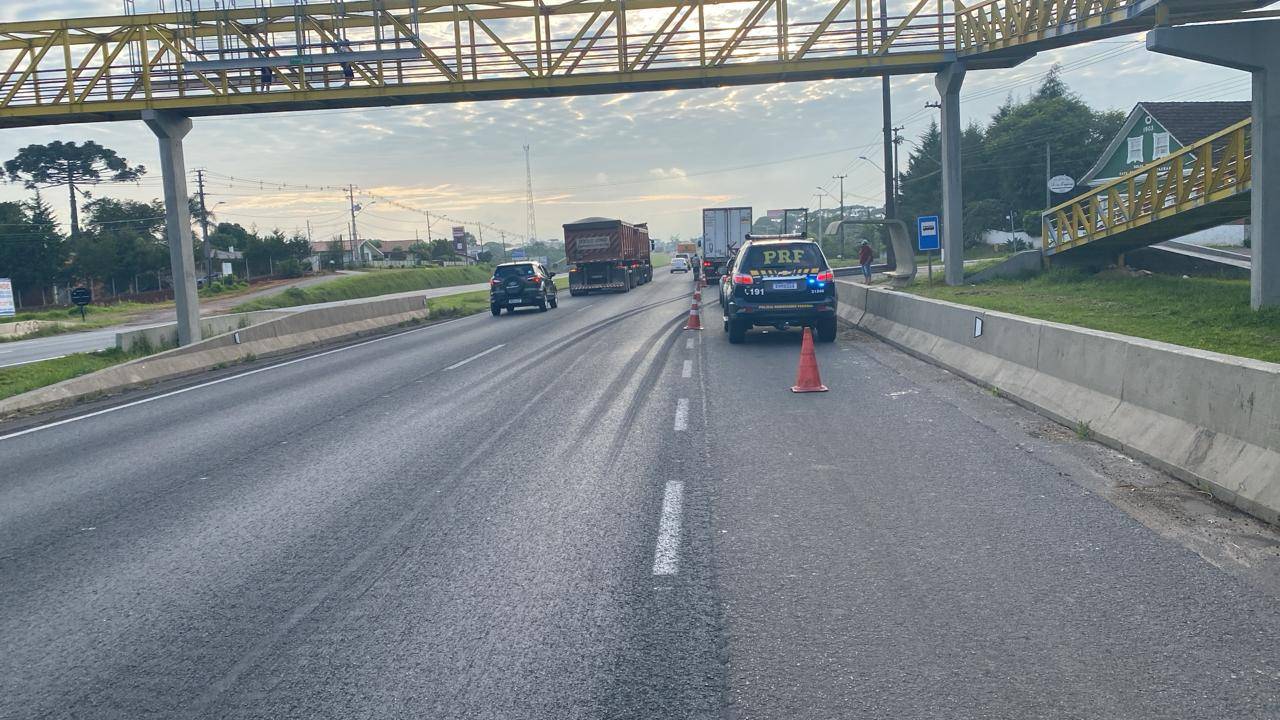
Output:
(564, 218), (653, 295)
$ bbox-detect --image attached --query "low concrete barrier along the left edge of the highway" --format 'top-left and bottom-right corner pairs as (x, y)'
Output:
(0, 296), (429, 418)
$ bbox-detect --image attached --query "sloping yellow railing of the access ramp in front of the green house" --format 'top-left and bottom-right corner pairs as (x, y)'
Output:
(1042, 120), (1253, 255)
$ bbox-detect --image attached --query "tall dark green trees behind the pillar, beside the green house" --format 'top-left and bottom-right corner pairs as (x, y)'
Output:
(899, 68), (1125, 246)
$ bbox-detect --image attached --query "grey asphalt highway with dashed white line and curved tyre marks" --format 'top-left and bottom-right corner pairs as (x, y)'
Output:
(0, 274), (1280, 720)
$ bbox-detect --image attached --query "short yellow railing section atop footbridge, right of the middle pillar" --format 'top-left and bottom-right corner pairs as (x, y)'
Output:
(956, 0), (1149, 55)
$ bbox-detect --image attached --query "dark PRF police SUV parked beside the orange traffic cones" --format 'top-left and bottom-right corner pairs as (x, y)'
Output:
(721, 236), (836, 343)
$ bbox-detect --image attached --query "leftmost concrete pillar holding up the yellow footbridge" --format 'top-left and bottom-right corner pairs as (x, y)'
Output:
(142, 110), (200, 345)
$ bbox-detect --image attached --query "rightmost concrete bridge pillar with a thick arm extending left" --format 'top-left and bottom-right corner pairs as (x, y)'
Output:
(1147, 20), (1280, 309)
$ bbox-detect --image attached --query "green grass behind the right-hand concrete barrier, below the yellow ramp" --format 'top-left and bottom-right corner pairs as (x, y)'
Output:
(908, 269), (1280, 363)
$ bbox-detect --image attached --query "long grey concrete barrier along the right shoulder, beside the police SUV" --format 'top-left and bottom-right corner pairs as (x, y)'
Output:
(837, 281), (1280, 523)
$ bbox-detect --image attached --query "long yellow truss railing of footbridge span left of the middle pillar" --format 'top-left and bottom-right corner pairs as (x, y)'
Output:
(0, 0), (954, 126)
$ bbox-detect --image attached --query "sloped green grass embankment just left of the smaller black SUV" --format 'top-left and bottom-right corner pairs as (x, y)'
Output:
(232, 265), (493, 313)
